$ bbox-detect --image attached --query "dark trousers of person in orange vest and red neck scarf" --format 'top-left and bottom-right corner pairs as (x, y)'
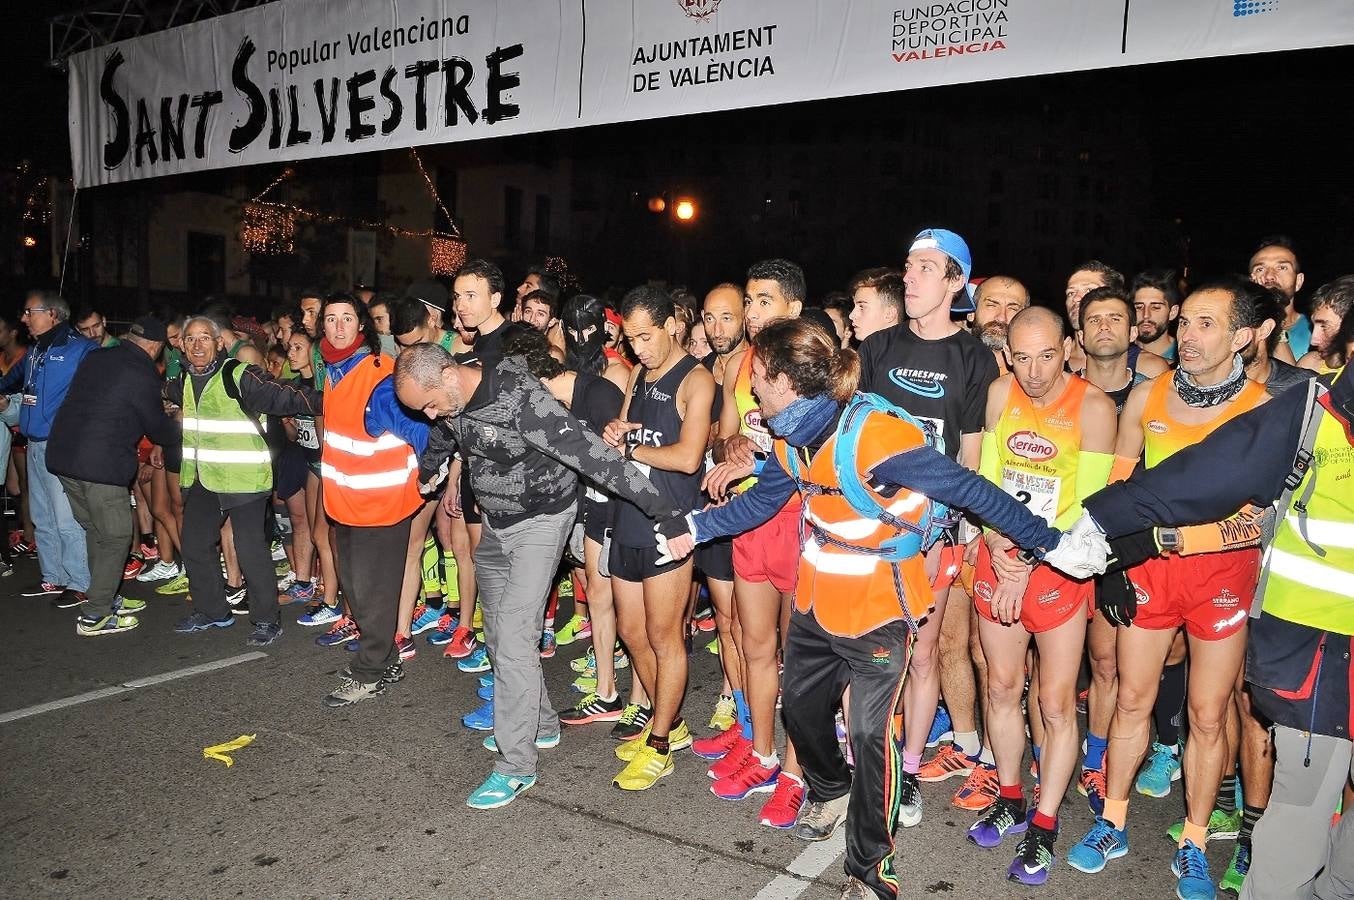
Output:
(334, 516), (413, 685)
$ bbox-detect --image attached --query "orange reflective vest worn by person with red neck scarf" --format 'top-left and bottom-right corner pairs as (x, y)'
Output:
(320, 356), (424, 526)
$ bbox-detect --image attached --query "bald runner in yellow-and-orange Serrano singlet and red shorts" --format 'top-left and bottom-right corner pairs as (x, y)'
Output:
(968, 306), (1117, 885)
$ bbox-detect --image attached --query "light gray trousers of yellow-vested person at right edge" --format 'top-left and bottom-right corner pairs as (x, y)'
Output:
(1240, 725), (1354, 900)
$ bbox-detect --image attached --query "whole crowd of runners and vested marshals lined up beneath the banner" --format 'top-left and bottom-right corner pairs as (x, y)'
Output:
(0, 229), (1354, 900)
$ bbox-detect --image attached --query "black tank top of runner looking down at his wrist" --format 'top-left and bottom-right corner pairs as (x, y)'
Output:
(612, 355), (703, 547)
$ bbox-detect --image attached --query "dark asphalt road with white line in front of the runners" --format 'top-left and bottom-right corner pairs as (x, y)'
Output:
(0, 560), (1231, 900)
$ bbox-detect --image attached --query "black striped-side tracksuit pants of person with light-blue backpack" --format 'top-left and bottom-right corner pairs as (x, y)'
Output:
(781, 610), (910, 899)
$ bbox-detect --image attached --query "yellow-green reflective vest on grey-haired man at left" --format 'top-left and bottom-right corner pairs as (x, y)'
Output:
(179, 363), (272, 494)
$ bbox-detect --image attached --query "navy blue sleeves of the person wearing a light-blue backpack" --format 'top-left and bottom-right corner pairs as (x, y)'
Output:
(693, 438), (1062, 549)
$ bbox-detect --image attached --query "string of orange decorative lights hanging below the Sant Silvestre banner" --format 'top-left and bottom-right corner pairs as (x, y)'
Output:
(240, 148), (467, 275)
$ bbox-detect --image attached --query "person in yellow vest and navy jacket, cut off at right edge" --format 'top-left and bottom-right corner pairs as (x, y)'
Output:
(1072, 368), (1354, 900)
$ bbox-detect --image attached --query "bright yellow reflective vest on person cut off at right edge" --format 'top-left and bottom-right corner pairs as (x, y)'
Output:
(1262, 413), (1354, 635)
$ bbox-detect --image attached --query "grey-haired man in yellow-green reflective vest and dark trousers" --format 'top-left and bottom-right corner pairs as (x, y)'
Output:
(168, 315), (320, 647)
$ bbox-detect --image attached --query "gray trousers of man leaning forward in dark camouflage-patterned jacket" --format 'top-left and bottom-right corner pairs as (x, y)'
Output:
(475, 509), (574, 775)
